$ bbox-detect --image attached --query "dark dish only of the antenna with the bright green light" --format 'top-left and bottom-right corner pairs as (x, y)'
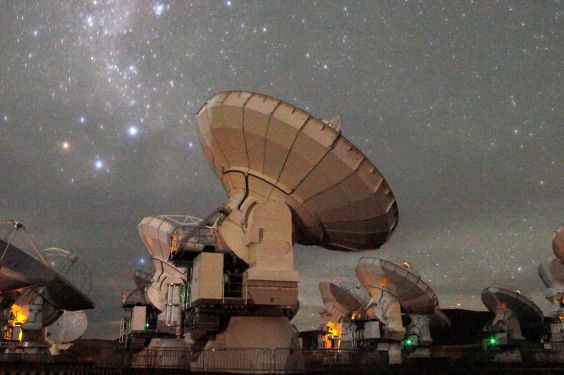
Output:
(482, 287), (543, 329)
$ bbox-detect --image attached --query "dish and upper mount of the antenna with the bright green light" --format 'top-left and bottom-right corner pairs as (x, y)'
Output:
(482, 287), (543, 343)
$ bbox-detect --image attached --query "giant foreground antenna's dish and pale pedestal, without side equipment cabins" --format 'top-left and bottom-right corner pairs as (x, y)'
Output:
(197, 91), (398, 356)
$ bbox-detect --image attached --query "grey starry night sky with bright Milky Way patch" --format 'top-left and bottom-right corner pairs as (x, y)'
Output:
(0, 0), (564, 338)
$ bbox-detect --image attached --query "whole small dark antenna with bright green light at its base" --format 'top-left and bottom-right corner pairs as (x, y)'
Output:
(482, 287), (543, 361)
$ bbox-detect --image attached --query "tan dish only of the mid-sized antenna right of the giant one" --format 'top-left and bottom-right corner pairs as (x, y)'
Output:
(355, 257), (439, 314)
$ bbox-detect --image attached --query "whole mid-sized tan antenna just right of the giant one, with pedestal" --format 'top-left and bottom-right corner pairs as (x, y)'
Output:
(355, 257), (439, 363)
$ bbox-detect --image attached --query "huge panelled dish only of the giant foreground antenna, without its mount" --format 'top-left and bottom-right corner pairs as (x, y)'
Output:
(198, 91), (398, 250)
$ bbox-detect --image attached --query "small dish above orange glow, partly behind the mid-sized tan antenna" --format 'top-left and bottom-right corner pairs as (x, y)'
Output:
(319, 281), (368, 322)
